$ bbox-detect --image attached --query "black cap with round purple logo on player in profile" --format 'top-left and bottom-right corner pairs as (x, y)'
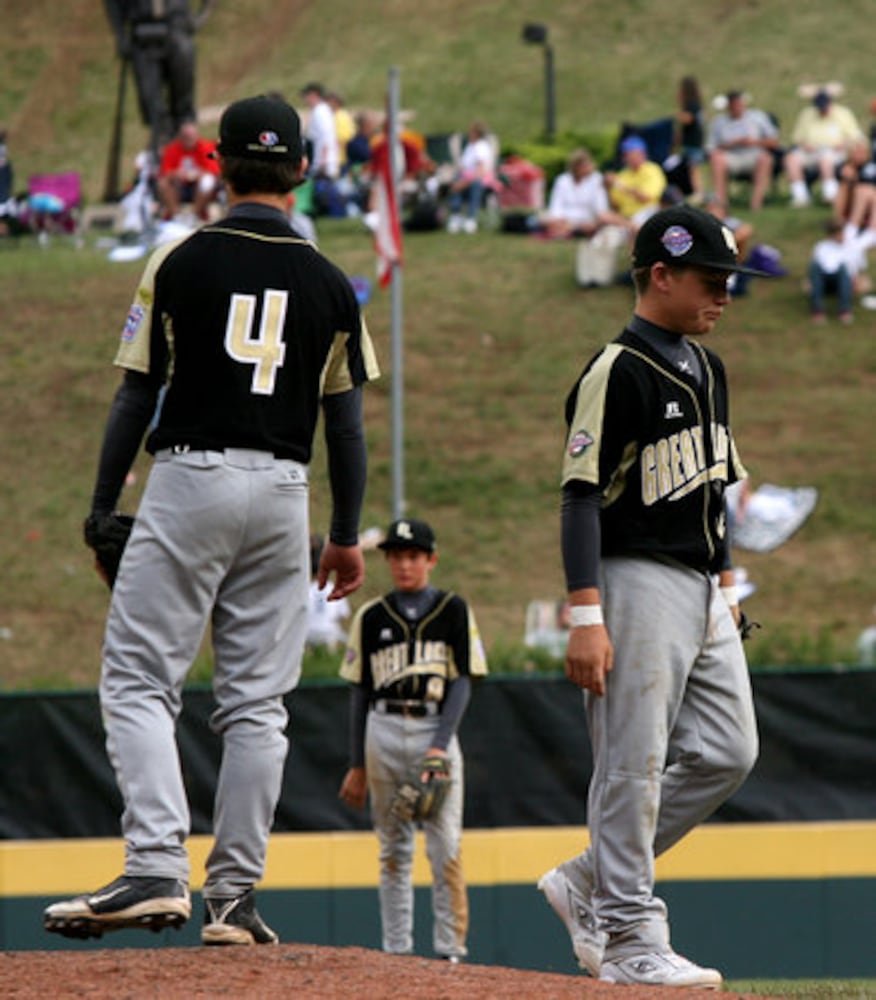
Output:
(633, 205), (772, 278)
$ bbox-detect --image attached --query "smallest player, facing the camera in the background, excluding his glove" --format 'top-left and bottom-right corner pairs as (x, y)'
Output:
(340, 518), (487, 962)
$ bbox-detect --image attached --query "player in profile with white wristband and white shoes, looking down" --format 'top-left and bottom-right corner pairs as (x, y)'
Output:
(539, 206), (757, 988)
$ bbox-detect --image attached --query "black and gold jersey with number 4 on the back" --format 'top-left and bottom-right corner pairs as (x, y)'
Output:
(116, 213), (378, 463)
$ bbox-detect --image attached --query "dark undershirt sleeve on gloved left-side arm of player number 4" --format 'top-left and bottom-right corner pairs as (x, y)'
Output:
(91, 371), (160, 514)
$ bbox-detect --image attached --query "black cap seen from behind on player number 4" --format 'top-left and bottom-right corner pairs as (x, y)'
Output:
(216, 95), (304, 163)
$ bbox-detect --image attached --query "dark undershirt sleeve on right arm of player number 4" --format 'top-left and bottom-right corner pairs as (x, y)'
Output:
(322, 386), (368, 545)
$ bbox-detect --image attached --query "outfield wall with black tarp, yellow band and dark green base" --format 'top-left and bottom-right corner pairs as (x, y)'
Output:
(0, 670), (876, 978)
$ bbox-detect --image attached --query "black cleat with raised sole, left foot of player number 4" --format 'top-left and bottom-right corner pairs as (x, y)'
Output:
(43, 875), (192, 938)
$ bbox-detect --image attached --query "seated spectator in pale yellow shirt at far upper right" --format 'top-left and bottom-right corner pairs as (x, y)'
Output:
(785, 89), (864, 208)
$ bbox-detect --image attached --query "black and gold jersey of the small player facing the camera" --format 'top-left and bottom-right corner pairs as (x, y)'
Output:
(341, 591), (487, 702)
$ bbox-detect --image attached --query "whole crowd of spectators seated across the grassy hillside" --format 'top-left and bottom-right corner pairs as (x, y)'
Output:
(6, 66), (876, 322)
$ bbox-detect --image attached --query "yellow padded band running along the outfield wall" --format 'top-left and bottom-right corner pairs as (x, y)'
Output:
(0, 822), (876, 897)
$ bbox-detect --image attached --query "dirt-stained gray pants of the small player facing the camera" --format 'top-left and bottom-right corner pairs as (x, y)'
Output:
(365, 710), (468, 956)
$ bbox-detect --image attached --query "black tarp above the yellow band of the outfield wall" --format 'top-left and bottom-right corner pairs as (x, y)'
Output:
(0, 670), (876, 840)
